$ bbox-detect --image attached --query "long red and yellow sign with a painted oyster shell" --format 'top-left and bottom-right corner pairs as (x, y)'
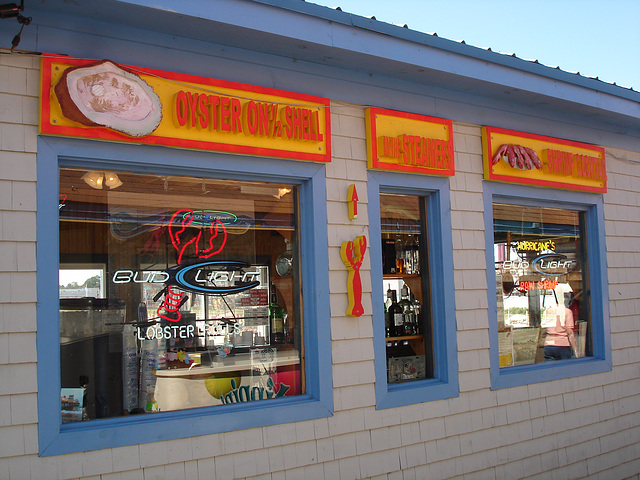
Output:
(40, 55), (331, 162)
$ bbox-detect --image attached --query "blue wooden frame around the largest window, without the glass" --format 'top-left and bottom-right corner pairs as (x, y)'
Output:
(37, 137), (333, 456)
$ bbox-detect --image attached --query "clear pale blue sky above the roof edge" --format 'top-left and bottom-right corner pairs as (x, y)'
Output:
(308, 0), (640, 91)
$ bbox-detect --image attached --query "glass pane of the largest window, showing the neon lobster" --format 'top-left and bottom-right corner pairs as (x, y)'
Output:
(59, 168), (305, 423)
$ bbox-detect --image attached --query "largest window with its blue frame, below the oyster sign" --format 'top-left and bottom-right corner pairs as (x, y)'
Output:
(38, 139), (332, 455)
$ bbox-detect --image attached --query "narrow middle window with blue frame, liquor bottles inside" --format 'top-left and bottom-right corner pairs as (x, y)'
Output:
(369, 172), (458, 408)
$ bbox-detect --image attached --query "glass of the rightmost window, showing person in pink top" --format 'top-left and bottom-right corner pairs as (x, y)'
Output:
(493, 203), (593, 368)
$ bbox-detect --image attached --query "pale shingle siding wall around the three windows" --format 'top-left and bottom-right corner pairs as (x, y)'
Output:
(0, 55), (640, 480)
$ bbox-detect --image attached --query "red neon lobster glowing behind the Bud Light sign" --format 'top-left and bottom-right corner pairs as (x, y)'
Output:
(157, 208), (227, 322)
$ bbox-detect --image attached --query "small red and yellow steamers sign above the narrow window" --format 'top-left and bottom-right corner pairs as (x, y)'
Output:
(365, 107), (455, 175)
